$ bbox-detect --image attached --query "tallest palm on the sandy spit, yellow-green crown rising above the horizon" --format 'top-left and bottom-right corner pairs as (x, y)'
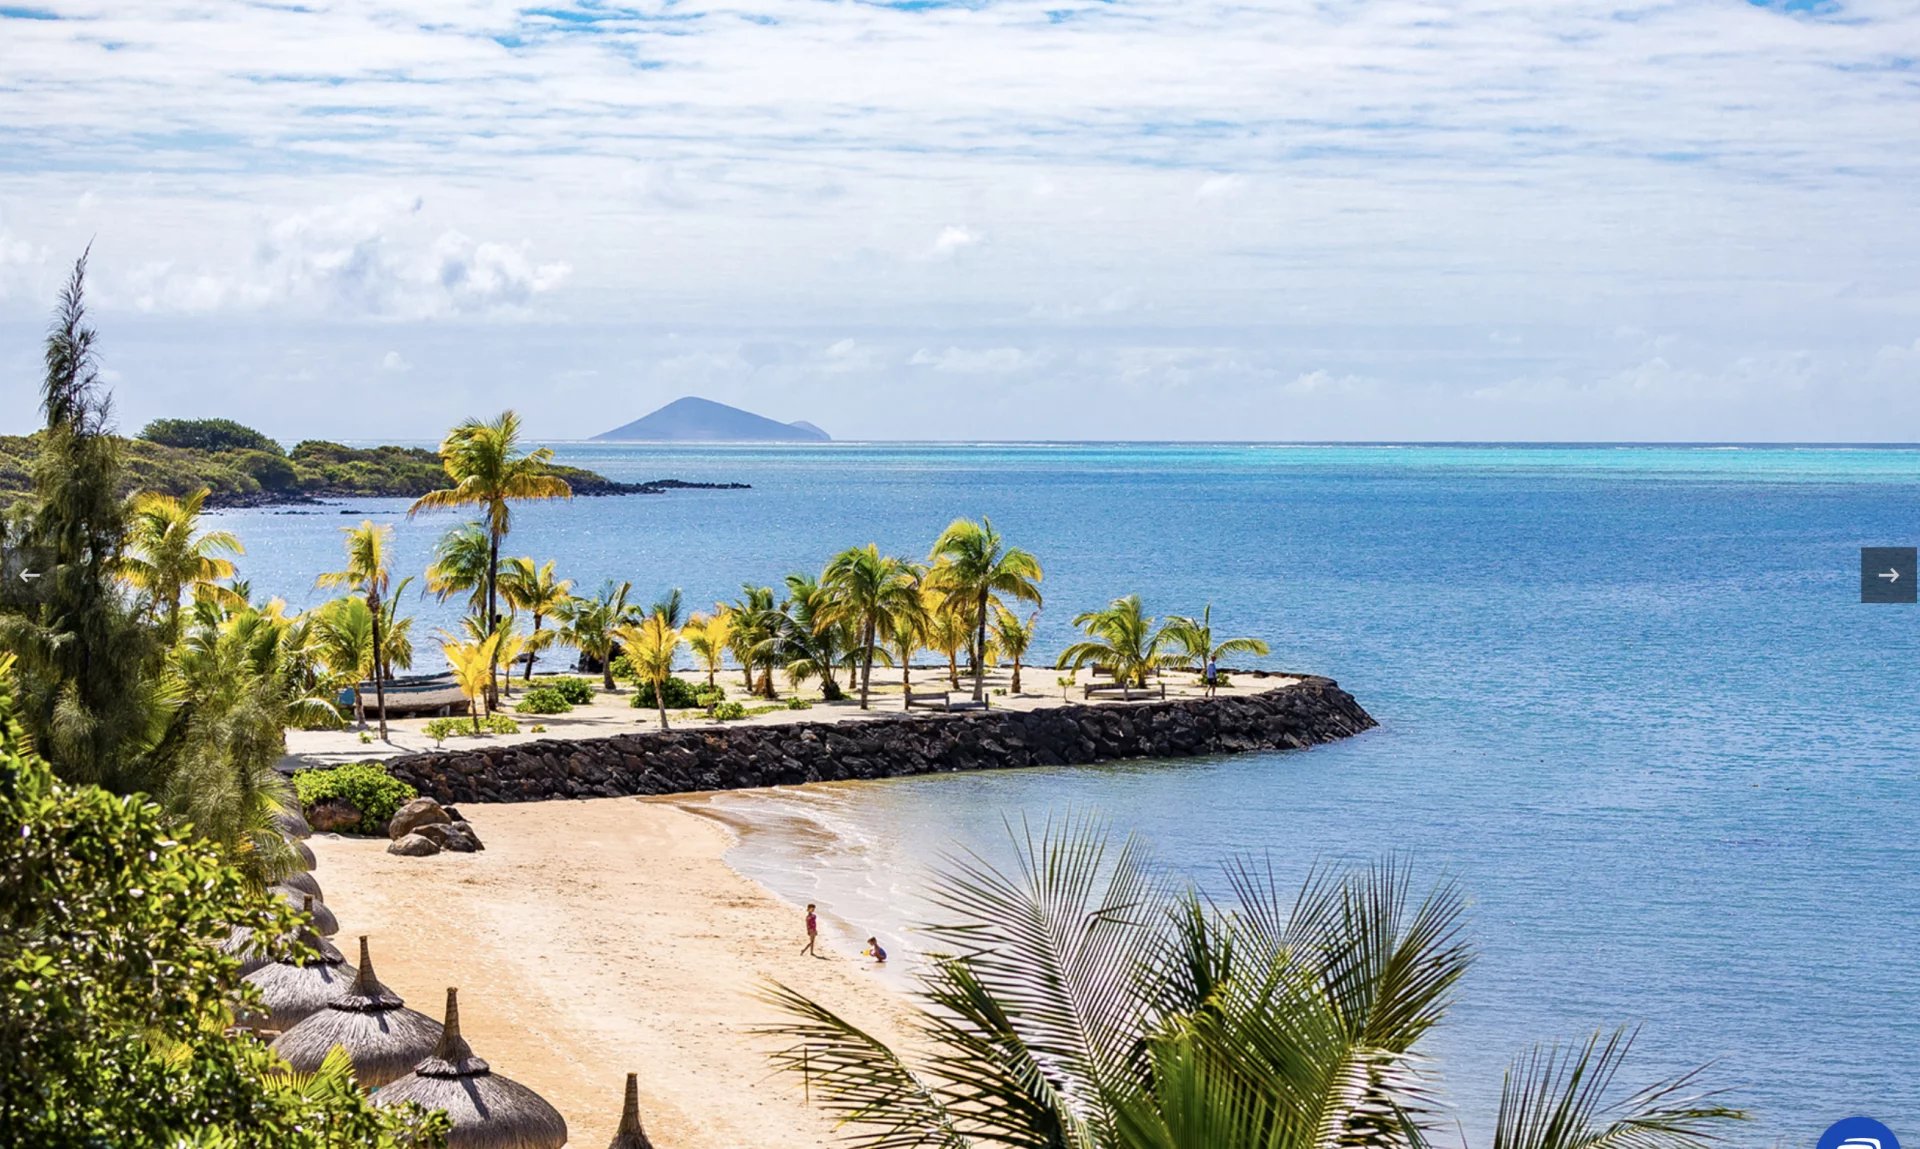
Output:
(407, 411), (574, 707)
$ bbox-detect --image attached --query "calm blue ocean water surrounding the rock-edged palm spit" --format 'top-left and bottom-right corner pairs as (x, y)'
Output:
(223, 444), (1920, 1145)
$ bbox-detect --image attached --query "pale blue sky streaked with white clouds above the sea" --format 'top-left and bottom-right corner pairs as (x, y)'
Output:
(0, 0), (1920, 442)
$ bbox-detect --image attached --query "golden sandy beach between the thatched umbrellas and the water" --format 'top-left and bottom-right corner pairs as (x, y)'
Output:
(311, 797), (917, 1149)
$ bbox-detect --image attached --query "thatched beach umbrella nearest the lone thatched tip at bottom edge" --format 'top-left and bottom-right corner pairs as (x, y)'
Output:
(372, 990), (566, 1149)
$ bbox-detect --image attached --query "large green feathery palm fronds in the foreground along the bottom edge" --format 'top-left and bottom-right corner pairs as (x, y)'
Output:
(766, 820), (1743, 1149)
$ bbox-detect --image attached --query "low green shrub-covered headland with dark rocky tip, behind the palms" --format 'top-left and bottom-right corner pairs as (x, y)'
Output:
(0, 411), (747, 507)
